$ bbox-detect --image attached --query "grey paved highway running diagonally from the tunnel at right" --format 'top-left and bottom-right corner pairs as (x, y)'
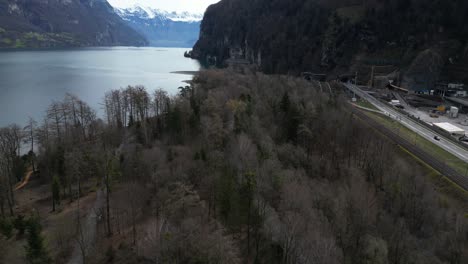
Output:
(343, 83), (468, 163)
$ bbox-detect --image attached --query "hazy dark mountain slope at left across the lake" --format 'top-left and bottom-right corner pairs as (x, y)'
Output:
(0, 0), (147, 48)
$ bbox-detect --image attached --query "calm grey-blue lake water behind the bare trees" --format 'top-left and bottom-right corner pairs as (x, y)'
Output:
(0, 47), (200, 127)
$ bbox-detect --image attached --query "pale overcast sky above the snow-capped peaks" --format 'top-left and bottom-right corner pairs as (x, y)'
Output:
(107, 0), (219, 13)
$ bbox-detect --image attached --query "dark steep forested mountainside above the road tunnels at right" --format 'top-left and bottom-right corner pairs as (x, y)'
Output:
(193, 0), (468, 80)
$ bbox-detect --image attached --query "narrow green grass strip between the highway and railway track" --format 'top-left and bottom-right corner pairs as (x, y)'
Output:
(366, 112), (468, 175)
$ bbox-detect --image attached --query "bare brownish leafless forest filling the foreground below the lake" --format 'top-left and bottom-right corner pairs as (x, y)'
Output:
(0, 70), (468, 264)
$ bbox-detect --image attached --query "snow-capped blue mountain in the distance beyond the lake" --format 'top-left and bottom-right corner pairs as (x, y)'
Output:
(116, 7), (203, 47)
